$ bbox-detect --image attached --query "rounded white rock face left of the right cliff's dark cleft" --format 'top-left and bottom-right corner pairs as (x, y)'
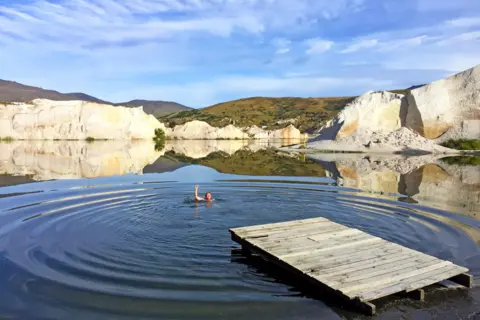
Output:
(315, 91), (403, 140)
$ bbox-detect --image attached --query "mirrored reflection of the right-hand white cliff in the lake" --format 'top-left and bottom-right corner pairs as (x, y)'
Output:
(309, 154), (480, 219)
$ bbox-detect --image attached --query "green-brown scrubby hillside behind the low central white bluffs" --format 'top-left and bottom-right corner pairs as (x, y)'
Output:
(161, 97), (355, 132)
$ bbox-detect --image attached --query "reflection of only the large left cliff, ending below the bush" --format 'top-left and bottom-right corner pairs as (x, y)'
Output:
(0, 141), (160, 181)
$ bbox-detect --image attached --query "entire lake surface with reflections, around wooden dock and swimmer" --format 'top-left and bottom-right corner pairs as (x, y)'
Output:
(0, 140), (480, 319)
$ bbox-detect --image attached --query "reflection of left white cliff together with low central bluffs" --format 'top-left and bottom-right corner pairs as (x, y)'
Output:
(0, 140), (297, 181)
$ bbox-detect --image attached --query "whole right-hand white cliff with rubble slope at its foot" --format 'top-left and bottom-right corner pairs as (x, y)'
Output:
(308, 66), (480, 152)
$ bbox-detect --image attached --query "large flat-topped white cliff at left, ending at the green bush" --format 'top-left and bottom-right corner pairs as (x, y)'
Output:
(0, 99), (165, 140)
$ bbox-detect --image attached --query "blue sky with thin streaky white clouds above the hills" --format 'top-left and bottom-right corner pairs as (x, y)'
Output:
(0, 0), (480, 107)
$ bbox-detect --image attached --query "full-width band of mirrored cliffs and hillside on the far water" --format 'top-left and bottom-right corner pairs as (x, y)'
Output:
(0, 140), (480, 219)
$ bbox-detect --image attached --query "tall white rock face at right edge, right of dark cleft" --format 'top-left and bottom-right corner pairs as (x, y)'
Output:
(406, 65), (480, 140)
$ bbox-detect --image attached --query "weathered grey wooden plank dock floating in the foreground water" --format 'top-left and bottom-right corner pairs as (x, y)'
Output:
(230, 218), (472, 315)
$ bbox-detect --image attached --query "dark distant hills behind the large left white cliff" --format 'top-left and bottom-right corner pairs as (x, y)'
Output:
(0, 80), (191, 117)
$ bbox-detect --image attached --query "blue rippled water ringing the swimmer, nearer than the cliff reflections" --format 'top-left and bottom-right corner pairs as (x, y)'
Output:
(0, 179), (480, 317)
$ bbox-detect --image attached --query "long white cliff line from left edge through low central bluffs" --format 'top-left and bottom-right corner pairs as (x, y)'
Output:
(0, 99), (303, 140)
